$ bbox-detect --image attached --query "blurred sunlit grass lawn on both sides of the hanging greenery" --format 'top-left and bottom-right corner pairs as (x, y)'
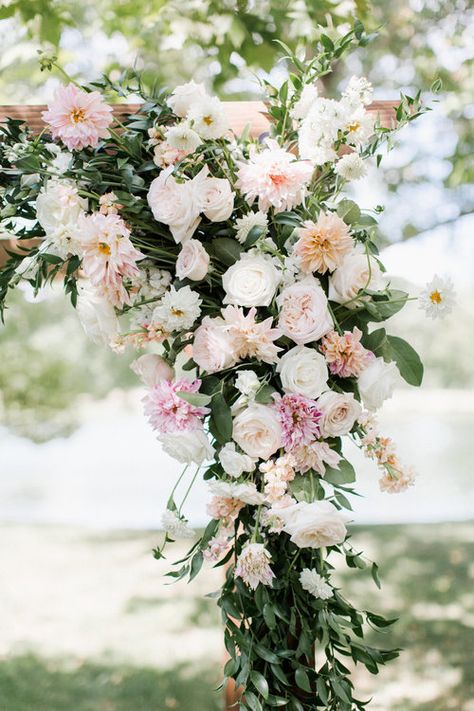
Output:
(0, 523), (474, 711)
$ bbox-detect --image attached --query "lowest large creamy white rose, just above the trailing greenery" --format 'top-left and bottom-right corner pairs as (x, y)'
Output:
(278, 501), (350, 548)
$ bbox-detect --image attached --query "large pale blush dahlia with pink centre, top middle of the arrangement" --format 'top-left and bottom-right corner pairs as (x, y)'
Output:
(236, 140), (313, 212)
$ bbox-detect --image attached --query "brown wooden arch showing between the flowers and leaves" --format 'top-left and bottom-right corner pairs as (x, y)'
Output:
(0, 100), (397, 711)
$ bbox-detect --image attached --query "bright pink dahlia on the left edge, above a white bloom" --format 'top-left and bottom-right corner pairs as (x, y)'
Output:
(144, 378), (209, 434)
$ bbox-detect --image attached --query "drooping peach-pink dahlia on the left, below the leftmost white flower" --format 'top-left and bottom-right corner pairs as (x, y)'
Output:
(77, 212), (144, 307)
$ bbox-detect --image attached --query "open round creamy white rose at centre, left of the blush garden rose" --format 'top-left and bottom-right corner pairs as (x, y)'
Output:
(222, 254), (281, 306)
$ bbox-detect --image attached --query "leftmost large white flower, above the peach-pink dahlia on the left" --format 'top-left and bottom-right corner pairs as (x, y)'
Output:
(36, 180), (87, 234)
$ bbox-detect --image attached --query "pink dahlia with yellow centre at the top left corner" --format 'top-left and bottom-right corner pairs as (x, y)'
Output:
(43, 84), (112, 151)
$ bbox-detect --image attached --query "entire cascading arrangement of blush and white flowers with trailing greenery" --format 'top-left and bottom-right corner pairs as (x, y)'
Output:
(0, 26), (453, 711)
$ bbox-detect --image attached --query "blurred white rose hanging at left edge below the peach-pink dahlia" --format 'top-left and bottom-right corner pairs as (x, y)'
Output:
(76, 287), (119, 344)
